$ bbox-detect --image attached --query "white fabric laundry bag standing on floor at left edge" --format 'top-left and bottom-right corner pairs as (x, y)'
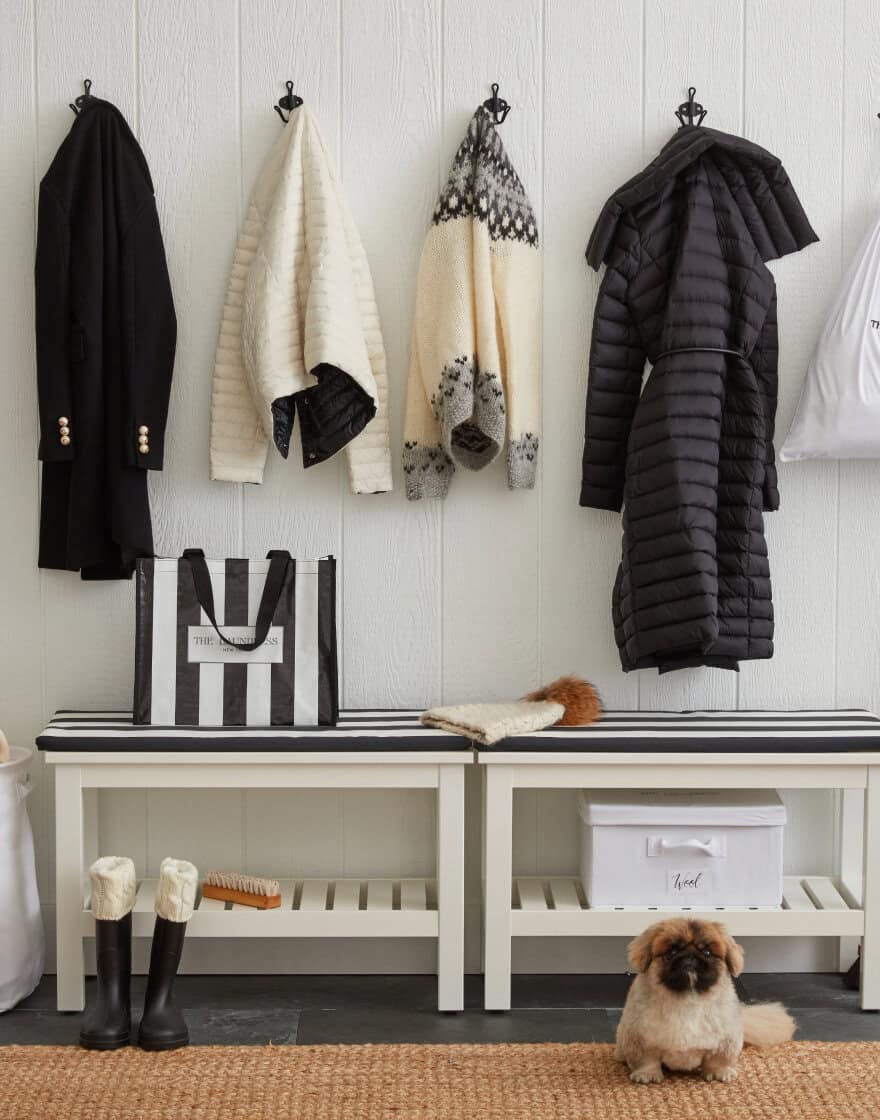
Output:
(0, 747), (45, 1011)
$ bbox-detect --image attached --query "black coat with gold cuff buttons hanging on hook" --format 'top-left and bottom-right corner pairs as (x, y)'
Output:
(36, 97), (177, 579)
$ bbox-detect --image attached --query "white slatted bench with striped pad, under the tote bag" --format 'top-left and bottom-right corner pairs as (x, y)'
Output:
(37, 711), (474, 1011)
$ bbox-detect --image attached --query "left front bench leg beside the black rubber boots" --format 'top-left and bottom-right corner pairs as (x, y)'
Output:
(55, 765), (85, 1011)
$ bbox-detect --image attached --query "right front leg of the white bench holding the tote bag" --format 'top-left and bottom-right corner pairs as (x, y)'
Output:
(437, 766), (465, 1011)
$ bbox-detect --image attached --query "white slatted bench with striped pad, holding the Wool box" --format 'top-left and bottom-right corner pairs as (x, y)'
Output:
(478, 711), (880, 1010)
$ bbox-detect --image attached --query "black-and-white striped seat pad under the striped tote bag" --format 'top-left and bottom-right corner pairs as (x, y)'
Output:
(37, 709), (471, 752)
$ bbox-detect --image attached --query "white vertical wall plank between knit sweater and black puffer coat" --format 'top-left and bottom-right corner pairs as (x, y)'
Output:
(537, 0), (642, 708)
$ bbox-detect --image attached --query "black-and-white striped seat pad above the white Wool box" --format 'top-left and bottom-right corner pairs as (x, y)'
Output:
(480, 709), (880, 754)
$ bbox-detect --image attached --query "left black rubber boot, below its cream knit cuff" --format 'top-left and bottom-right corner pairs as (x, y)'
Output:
(79, 911), (131, 1049)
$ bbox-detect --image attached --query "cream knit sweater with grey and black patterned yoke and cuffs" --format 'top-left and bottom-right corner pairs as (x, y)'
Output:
(403, 108), (542, 500)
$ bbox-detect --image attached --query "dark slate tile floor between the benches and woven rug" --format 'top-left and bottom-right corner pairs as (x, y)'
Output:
(0, 973), (880, 1046)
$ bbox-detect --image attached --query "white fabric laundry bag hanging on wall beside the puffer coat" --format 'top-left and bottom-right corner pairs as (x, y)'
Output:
(779, 211), (880, 461)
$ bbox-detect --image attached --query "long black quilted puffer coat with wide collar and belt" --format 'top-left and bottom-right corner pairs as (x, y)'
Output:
(580, 125), (817, 672)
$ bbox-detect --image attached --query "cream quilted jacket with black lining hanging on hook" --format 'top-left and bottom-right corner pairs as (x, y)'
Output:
(210, 105), (392, 494)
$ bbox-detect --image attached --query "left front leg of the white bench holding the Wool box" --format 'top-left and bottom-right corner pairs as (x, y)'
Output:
(483, 766), (513, 1011)
